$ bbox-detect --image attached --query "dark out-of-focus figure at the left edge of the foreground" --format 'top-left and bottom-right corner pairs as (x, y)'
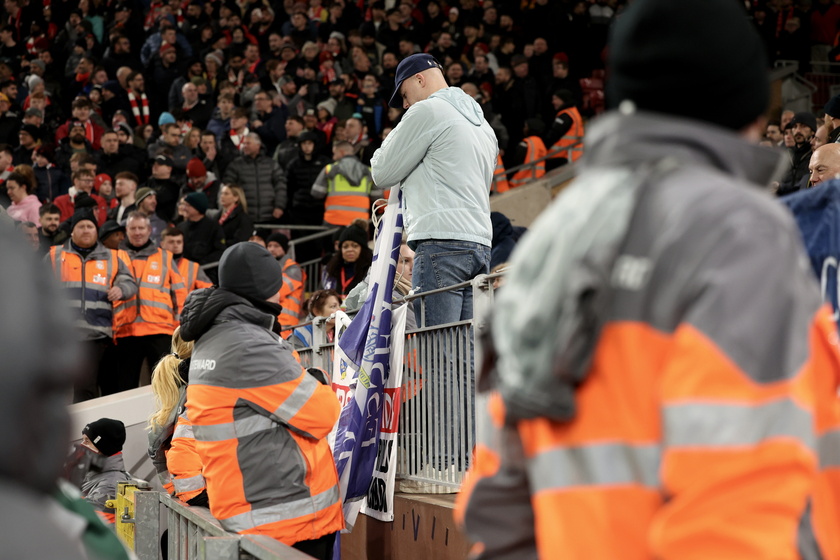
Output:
(0, 230), (128, 560)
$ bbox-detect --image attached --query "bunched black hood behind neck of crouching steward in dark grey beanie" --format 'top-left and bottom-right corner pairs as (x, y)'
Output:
(181, 288), (279, 342)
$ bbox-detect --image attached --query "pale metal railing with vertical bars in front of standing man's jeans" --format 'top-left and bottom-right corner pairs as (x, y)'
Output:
(298, 273), (503, 493)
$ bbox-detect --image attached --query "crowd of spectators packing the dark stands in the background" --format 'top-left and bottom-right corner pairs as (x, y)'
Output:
(8, 0), (840, 398)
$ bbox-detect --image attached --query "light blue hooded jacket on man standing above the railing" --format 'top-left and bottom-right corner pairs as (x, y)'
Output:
(371, 87), (499, 247)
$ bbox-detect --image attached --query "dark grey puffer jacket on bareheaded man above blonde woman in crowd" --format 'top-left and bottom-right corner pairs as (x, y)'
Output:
(222, 154), (286, 223)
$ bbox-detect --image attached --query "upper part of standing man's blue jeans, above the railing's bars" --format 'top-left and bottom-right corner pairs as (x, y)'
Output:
(411, 240), (490, 327)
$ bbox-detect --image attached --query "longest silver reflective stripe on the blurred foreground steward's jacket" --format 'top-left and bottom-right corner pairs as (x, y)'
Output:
(663, 398), (816, 449)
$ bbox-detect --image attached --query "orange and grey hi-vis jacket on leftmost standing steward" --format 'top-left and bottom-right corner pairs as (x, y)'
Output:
(50, 245), (130, 338)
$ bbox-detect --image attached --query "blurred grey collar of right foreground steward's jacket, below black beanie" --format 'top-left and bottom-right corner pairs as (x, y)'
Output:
(583, 111), (785, 186)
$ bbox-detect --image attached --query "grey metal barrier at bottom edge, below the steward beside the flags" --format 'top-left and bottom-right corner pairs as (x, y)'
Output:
(133, 491), (311, 560)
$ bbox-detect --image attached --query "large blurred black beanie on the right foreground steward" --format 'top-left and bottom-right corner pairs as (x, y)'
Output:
(606, 0), (770, 130)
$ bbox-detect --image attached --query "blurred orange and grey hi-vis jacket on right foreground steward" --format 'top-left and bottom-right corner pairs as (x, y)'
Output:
(458, 110), (840, 560)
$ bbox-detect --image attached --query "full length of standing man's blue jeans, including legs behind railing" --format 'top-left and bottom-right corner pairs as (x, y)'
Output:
(412, 240), (490, 471)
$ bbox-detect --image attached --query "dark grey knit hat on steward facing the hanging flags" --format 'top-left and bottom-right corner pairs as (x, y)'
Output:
(219, 243), (283, 300)
